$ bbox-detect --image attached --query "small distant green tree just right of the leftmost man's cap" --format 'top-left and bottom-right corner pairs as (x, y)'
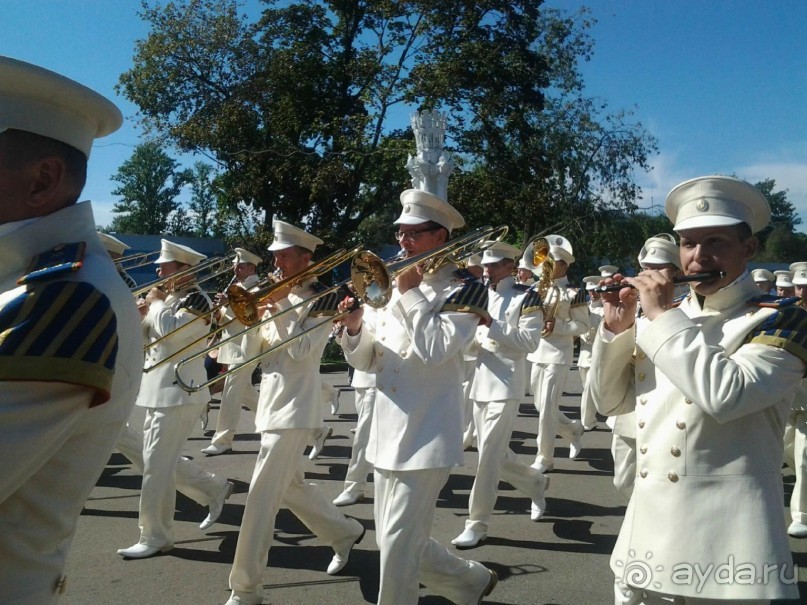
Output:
(110, 142), (188, 235)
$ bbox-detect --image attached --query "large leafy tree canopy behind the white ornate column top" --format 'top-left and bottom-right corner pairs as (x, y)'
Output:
(120, 0), (655, 252)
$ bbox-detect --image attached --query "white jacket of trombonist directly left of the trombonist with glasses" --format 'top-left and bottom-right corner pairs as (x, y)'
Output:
(255, 278), (331, 432)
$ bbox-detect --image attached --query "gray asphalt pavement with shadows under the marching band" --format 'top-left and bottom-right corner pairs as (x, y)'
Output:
(61, 371), (807, 605)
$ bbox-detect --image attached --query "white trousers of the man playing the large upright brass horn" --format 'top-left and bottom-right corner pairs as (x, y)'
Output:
(530, 363), (582, 465)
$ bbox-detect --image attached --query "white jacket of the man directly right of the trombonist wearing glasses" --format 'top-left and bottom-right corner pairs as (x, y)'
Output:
(470, 277), (544, 401)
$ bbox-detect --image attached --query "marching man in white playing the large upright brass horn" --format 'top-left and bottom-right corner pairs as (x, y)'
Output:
(527, 235), (589, 473)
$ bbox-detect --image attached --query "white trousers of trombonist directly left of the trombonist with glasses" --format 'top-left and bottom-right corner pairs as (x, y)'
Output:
(230, 429), (357, 603)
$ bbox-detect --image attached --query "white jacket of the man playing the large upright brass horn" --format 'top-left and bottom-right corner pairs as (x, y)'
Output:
(527, 277), (589, 366)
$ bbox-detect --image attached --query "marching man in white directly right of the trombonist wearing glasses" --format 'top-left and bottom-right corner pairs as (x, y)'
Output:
(451, 242), (549, 548)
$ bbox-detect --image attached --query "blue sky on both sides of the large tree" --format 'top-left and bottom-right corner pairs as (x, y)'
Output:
(6, 0), (807, 233)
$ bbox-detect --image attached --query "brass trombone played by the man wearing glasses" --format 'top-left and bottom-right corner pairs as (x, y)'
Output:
(174, 225), (508, 393)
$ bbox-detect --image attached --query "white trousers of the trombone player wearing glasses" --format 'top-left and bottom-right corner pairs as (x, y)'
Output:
(375, 468), (490, 605)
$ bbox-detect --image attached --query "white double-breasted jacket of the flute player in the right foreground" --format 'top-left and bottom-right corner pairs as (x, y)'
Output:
(589, 274), (807, 599)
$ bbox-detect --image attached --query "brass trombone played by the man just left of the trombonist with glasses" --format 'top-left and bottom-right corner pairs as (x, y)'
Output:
(143, 246), (361, 372)
